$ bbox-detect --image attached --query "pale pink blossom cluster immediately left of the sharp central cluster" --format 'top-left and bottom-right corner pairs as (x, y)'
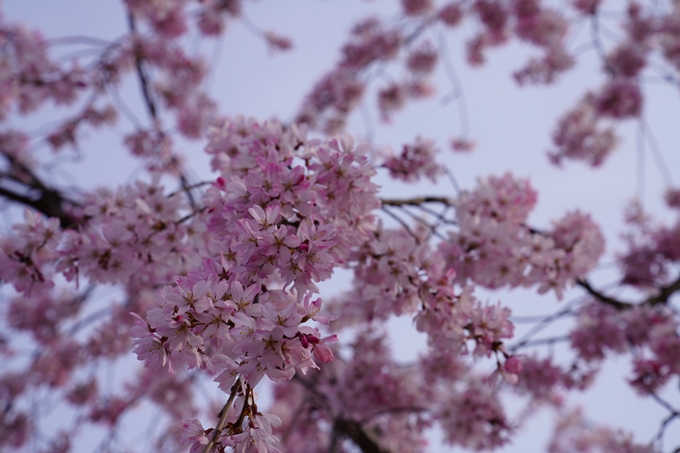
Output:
(57, 181), (201, 288)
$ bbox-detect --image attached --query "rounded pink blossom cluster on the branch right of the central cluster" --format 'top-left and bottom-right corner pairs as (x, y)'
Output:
(439, 175), (604, 297)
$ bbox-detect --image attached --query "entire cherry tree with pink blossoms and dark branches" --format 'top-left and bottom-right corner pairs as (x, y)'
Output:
(0, 0), (680, 453)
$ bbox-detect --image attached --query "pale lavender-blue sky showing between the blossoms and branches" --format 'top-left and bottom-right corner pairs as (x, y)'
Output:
(2, 0), (680, 452)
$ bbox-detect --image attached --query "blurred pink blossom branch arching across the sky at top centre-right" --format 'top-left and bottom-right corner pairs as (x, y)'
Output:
(297, 0), (574, 133)
